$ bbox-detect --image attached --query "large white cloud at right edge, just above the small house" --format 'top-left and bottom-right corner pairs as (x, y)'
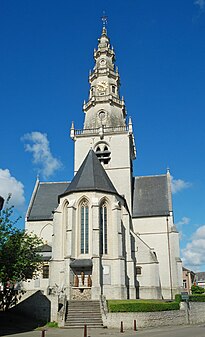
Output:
(182, 225), (205, 270)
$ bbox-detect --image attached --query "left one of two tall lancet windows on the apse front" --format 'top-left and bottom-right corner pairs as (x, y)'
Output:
(80, 200), (89, 254)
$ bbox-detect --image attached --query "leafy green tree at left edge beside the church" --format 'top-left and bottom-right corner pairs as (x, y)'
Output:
(0, 197), (42, 310)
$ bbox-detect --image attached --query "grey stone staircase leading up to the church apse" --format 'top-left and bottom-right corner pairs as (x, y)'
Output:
(65, 301), (103, 328)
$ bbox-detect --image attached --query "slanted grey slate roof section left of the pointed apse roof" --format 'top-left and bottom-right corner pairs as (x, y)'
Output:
(27, 182), (69, 221)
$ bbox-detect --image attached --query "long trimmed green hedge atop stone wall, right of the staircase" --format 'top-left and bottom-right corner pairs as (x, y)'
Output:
(108, 300), (180, 312)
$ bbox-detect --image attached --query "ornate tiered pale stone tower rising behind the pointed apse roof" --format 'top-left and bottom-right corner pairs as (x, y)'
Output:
(70, 27), (136, 210)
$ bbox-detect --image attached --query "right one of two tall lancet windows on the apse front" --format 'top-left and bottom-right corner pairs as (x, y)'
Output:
(100, 202), (107, 254)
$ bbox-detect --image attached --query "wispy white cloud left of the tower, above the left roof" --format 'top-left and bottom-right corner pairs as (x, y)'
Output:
(22, 131), (62, 178)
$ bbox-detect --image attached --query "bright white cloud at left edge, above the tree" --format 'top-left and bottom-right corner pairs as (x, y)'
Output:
(0, 169), (25, 209)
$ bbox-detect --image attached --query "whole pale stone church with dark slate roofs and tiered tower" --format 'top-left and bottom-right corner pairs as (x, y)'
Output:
(25, 26), (182, 312)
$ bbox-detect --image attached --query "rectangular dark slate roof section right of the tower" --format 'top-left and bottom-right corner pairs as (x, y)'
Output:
(133, 175), (170, 218)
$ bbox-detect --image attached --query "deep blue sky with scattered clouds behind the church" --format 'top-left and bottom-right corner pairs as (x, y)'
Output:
(0, 0), (205, 271)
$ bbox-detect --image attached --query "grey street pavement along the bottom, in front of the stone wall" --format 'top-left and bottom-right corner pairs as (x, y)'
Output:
(0, 325), (205, 337)
